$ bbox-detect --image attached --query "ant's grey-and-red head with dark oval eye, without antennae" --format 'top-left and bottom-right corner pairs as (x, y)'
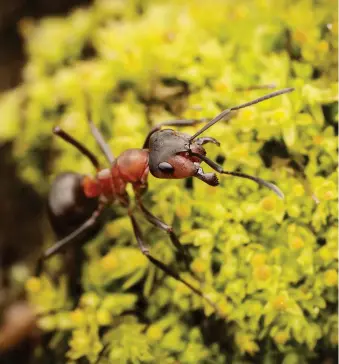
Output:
(149, 129), (210, 179)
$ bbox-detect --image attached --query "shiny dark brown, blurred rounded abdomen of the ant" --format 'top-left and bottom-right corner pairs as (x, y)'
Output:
(47, 172), (99, 240)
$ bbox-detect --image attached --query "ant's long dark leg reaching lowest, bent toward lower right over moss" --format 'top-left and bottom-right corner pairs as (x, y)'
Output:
(129, 212), (222, 316)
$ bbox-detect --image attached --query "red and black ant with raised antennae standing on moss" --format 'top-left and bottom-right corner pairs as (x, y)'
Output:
(43, 88), (294, 308)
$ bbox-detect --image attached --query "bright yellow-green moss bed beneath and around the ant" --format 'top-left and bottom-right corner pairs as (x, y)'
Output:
(0, 0), (338, 364)
